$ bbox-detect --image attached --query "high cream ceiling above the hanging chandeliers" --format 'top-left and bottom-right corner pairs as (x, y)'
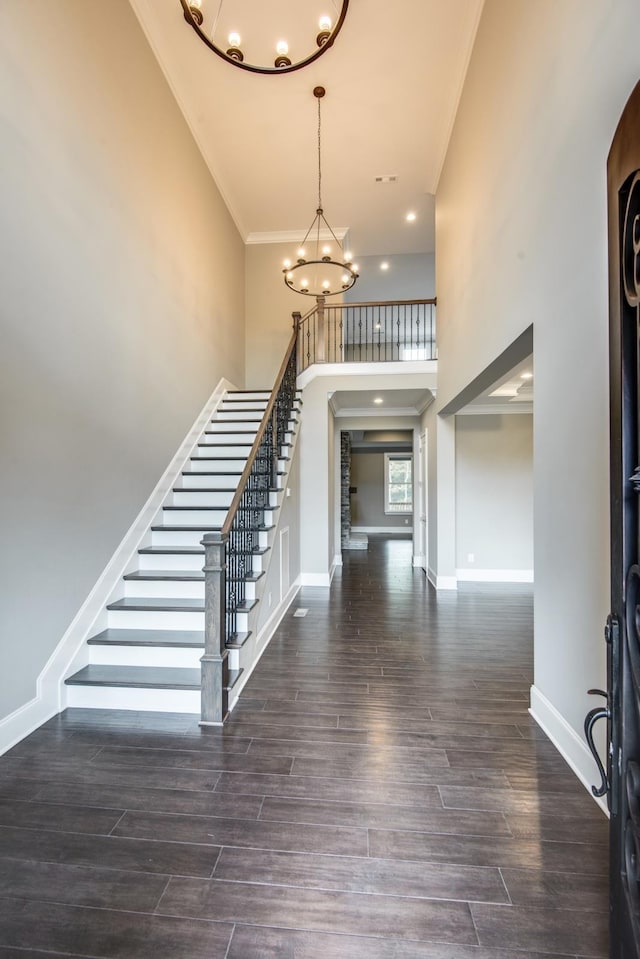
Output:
(130, 0), (483, 256)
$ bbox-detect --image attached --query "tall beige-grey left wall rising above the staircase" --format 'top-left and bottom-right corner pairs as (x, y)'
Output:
(0, 0), (244, 716)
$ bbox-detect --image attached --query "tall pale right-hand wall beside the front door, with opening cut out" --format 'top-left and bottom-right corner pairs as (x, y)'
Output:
(436, 0), (640, 778)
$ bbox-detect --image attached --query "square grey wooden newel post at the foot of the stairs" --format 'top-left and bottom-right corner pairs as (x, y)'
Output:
(200, 532), (229, 726)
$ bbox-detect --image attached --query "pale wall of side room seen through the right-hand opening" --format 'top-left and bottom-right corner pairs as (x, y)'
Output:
(456, 413), (533, 582)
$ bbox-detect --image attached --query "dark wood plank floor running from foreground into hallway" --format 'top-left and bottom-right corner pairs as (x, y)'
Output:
(0, 537), (607, 959)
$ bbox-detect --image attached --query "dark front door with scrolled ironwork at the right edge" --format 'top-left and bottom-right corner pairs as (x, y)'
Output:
(606, 83), (640, 959)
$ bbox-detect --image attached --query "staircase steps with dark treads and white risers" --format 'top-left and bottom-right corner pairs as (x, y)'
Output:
(65, 391), (300, 713)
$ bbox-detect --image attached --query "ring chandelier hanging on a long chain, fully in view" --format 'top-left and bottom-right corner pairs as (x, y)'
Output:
(282, 87), (358, 297)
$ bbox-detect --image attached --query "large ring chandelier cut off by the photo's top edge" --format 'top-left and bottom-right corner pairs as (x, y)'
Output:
(180, 0), (349, 73)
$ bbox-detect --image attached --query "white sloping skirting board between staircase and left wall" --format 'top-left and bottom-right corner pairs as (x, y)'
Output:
(17, 378), (235, 751)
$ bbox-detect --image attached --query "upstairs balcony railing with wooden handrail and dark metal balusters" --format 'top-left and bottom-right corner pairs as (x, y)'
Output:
(298, 297), (436, 373)
